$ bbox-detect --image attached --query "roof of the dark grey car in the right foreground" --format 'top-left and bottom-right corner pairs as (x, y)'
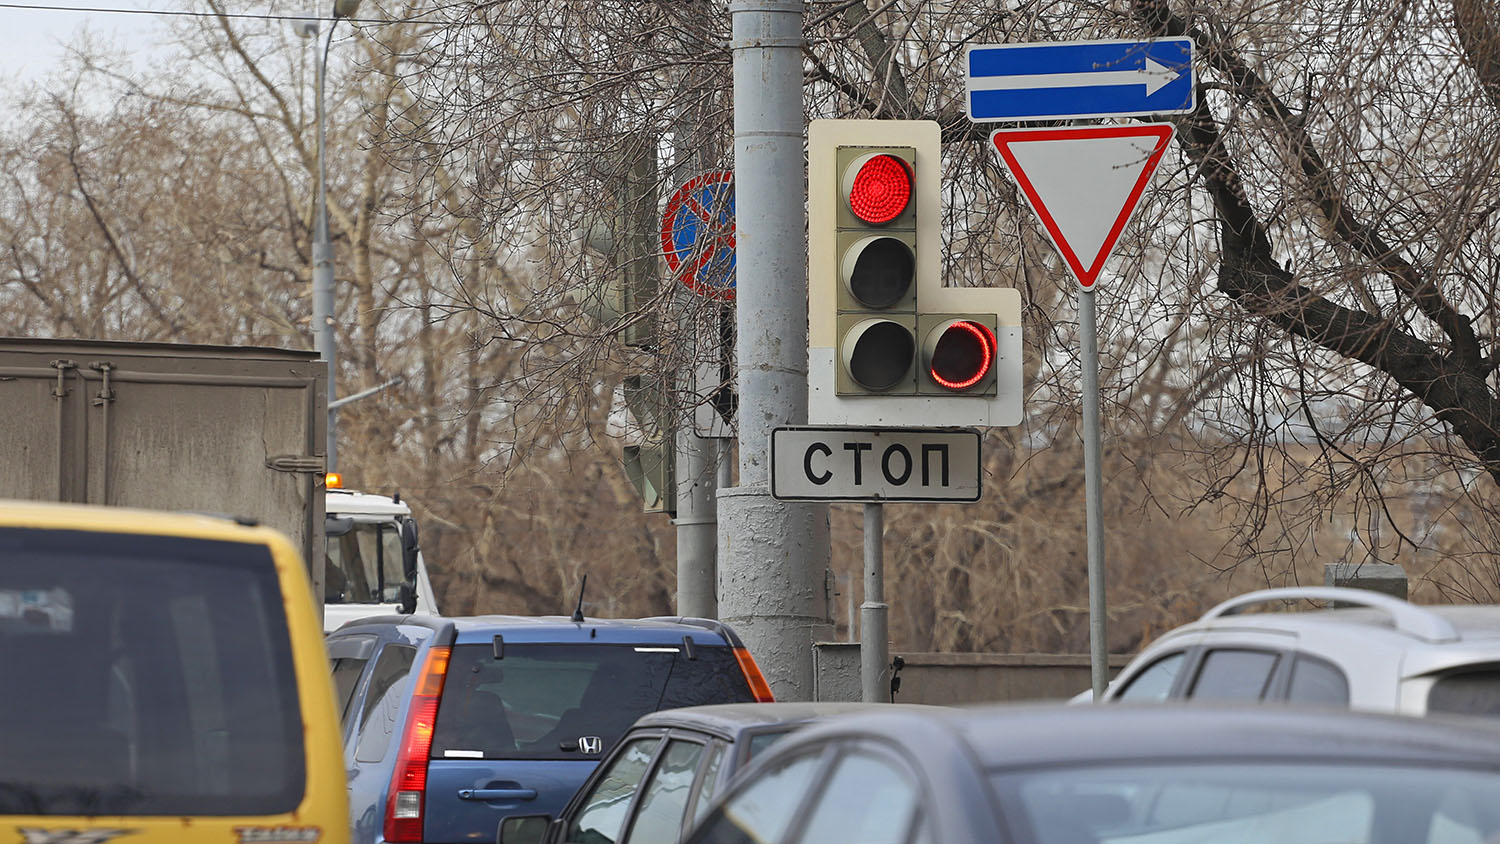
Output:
(797, 703), (1500, 772)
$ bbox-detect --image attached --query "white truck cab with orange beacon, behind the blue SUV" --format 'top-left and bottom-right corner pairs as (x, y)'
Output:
(323, 477), (438, 633)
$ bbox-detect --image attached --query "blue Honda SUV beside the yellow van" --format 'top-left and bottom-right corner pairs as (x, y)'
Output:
(327, 615), (771, 844)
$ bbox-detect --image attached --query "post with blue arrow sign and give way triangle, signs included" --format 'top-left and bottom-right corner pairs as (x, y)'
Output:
(965, 37), (1197, 700)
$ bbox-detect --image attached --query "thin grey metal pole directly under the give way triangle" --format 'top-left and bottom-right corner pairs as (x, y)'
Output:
(1079, 288), (1110, 700)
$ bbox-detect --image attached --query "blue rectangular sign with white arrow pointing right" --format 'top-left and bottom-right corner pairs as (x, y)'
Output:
(965, 37), (1196, 121)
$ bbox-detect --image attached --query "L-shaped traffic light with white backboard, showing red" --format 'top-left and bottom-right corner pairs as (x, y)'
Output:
(807, 120), (1020, 427)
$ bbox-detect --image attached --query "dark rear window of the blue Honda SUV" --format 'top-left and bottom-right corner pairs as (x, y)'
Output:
(432, 645), (753, 759)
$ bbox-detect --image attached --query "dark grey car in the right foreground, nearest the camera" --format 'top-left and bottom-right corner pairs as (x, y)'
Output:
(684, 705), (1500, 844)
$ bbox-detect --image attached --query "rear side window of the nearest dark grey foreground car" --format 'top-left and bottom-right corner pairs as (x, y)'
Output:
(798, 751), (918, 844)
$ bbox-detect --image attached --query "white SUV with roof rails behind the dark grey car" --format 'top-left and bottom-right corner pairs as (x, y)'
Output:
(1098, 586), (1500, 715)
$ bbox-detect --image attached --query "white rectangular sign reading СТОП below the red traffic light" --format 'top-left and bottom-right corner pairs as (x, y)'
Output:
(771, 427), (981, 502)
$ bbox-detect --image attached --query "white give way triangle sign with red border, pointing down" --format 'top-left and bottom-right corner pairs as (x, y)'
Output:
(990, 123), (1175, 289)
